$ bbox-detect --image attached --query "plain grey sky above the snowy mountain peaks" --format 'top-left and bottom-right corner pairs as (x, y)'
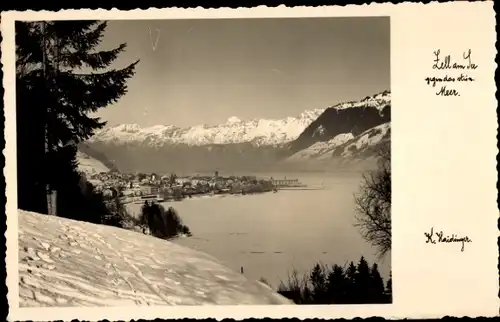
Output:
(97, 17), (390, 127)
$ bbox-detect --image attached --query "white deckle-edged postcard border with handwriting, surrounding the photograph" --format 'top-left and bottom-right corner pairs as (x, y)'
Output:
(1, 2), (499, 320)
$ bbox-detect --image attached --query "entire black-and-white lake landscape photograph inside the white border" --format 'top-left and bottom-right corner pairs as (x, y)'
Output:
(15, 16), (393, 307)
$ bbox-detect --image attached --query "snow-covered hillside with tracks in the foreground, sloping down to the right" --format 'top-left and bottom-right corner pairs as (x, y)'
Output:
(19, 210), (292, 307)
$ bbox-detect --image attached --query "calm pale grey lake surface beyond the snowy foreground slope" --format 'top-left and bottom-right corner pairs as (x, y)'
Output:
(126, 173), (390, 287)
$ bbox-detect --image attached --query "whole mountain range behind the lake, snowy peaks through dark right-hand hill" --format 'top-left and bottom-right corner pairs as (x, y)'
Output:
(85, 91), (391, 172)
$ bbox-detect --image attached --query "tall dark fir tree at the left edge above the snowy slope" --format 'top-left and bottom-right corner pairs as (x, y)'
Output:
(16, 21), (138, 218)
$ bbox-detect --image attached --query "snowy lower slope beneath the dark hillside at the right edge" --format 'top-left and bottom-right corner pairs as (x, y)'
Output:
(286, 122), (391, 162)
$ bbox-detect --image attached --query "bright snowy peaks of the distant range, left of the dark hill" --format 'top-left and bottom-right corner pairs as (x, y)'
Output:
(89, 108), (325, 146)
